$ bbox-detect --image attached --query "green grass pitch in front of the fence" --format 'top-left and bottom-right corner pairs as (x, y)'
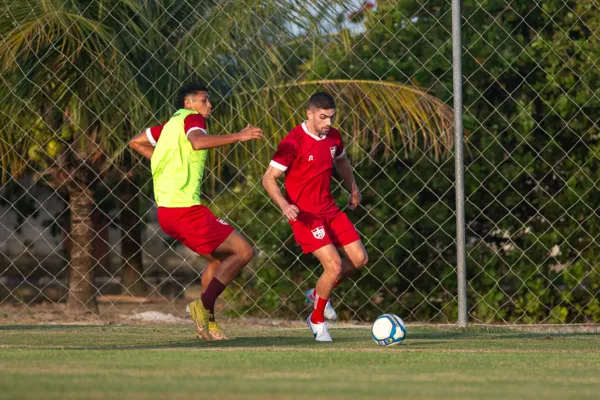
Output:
(0, 326), (600, 400)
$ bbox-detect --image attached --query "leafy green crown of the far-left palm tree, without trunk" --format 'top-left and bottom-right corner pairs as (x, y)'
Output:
(0, 0), (148, 183)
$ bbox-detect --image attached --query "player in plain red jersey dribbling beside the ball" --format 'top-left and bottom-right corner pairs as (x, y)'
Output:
(263, 92), (368, 342)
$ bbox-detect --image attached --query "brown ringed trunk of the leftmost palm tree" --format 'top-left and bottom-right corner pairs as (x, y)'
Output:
(67, 188), (98, 313)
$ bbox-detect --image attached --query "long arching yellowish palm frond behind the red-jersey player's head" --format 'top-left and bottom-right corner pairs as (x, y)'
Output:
(213, 80), (453, 177)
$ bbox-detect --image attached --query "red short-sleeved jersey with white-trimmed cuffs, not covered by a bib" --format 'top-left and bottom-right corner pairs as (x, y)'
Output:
(271, 122), (344, 217)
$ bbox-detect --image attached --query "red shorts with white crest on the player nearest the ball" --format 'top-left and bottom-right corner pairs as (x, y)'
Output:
(290, 211), (360, 254)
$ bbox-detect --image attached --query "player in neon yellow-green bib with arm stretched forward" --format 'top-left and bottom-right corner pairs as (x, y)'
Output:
(129, 83), (264, 341)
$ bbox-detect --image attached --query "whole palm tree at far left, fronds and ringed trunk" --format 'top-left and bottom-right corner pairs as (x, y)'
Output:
(0, 1), (144, 312)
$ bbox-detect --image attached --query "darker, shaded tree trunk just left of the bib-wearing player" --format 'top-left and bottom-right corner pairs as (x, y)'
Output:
(119, 179), (145, 296)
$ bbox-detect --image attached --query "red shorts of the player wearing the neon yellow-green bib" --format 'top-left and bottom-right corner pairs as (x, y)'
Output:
(158, 205), (233, 254)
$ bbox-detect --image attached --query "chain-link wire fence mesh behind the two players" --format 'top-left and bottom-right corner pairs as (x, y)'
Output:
(0, 0), (600, 323)
